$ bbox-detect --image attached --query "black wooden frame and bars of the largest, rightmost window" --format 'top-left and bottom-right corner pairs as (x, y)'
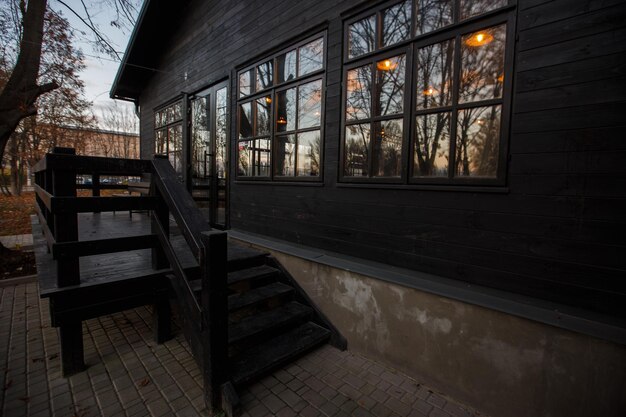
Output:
(338, 0), (517, 185)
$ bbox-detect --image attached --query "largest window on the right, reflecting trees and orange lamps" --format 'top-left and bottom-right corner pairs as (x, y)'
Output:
(340, 0), (513, 184)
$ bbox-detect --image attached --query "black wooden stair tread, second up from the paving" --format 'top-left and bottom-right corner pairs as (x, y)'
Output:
(228, 301), (313, 343)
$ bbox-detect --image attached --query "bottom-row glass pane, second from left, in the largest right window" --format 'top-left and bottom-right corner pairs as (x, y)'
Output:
(372, 119), (402, 177)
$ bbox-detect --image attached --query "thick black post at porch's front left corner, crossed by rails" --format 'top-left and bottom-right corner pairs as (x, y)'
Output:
(52, 148), (85, 376)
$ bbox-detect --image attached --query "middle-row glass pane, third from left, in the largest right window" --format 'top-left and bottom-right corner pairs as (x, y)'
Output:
(416, 39), (454, 109)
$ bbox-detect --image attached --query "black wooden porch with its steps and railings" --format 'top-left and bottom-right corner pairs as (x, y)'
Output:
(35, 149), (345, 415)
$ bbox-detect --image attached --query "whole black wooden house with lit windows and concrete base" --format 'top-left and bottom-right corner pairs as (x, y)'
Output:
(111, 0), (626, 416)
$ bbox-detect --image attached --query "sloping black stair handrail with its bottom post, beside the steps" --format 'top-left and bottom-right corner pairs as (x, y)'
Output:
(150, 156), (228, 410)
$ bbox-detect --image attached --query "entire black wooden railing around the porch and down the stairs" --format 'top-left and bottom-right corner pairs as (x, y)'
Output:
(34, 148), (228, 410)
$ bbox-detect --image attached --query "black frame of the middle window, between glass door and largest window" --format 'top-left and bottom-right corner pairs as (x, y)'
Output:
(234, 30), (328, 183)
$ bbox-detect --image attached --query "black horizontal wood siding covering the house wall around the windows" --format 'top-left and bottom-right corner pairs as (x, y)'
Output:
(136, 0), (626, 317)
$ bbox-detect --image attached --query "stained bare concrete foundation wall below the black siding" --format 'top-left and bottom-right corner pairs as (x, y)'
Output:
(238, 242), (626, 417)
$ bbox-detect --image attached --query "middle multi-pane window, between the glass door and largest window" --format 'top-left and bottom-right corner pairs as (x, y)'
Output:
(237, 35), (326, 181)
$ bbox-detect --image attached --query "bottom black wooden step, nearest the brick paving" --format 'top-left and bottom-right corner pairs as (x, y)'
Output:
(230, 322), (330, 386)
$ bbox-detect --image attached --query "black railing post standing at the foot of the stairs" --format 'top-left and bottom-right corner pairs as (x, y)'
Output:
(200, 231), (228, 411)
